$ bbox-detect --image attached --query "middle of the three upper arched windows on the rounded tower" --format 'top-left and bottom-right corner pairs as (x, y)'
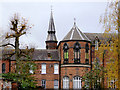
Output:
(74, 42), (81, 63)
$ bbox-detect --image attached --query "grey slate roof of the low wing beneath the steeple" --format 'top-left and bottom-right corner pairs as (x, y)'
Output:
(2, 49), (60, 60)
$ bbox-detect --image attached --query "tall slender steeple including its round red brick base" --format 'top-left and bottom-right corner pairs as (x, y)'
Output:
(46, 8), (57, 49)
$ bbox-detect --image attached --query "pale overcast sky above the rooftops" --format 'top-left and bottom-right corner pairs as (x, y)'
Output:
(0, 0), (107, 49)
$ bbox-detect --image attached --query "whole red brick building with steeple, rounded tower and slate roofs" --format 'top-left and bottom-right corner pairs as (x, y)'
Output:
(0, 12), (109, 89)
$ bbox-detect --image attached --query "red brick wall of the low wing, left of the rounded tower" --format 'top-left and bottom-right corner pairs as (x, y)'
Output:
(11, 60), (59, 88)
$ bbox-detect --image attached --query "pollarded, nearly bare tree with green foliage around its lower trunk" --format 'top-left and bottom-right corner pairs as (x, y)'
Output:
(1, 14), (35, 87)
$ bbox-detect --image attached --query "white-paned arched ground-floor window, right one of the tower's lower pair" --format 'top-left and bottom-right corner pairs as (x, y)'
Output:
(73, 76), (82, 89)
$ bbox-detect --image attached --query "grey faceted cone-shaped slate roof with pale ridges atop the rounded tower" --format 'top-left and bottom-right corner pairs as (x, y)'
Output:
(62, 22), (90, 41)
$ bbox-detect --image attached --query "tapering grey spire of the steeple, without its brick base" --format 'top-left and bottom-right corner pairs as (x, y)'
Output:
(46, 9), (57, 41)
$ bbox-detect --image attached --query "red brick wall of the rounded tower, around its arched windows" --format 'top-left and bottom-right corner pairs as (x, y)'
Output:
(58, 41), (94, 88)
